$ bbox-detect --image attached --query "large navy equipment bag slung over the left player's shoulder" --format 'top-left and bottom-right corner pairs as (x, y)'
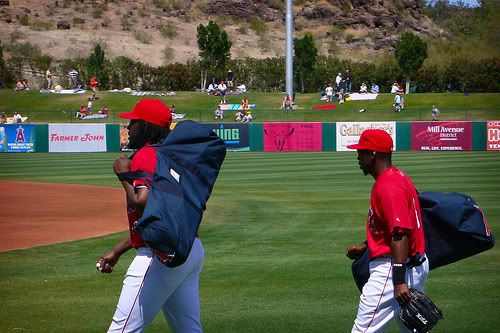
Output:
(119, 120), (226, 267)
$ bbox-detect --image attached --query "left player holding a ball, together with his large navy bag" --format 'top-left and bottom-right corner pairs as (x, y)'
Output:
(100, 98), (226, 333)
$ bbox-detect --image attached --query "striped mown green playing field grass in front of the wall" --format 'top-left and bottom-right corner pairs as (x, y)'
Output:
(0, 152), (500, 333)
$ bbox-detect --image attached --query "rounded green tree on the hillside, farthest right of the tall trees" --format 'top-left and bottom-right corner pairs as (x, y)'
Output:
(394, 32), (427, 94)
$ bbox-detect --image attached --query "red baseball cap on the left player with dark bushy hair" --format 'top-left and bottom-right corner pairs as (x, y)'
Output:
(120, 98), (172, 127)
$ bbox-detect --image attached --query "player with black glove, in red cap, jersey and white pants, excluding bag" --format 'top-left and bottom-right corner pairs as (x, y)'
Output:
(346, 129), (429, 332)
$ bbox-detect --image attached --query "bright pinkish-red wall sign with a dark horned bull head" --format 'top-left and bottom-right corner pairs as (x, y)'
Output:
(264, 123), (322, 151)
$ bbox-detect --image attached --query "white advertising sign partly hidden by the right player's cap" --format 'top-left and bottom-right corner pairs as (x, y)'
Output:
(337, 121), (396, 151)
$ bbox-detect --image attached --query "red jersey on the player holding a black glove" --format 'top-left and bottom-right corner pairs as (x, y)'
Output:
(366, 167), (425, 259)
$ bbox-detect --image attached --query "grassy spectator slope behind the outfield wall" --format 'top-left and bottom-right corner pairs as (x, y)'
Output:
(0, 89), (500, 123)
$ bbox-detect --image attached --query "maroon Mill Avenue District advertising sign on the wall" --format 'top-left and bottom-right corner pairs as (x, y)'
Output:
(411, 121), (472, 150)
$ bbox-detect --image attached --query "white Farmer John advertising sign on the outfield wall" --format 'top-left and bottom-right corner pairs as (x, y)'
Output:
(49, 124), (106, 152)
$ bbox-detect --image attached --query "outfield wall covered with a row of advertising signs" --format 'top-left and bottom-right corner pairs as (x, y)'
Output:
(0, 120), (500, 152)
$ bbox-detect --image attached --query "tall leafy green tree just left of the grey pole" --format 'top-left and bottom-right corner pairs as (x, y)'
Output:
(196, 21), (232, 89)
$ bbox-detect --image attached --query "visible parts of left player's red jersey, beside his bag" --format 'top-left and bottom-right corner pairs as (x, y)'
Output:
(127, 145), (156, 248)
